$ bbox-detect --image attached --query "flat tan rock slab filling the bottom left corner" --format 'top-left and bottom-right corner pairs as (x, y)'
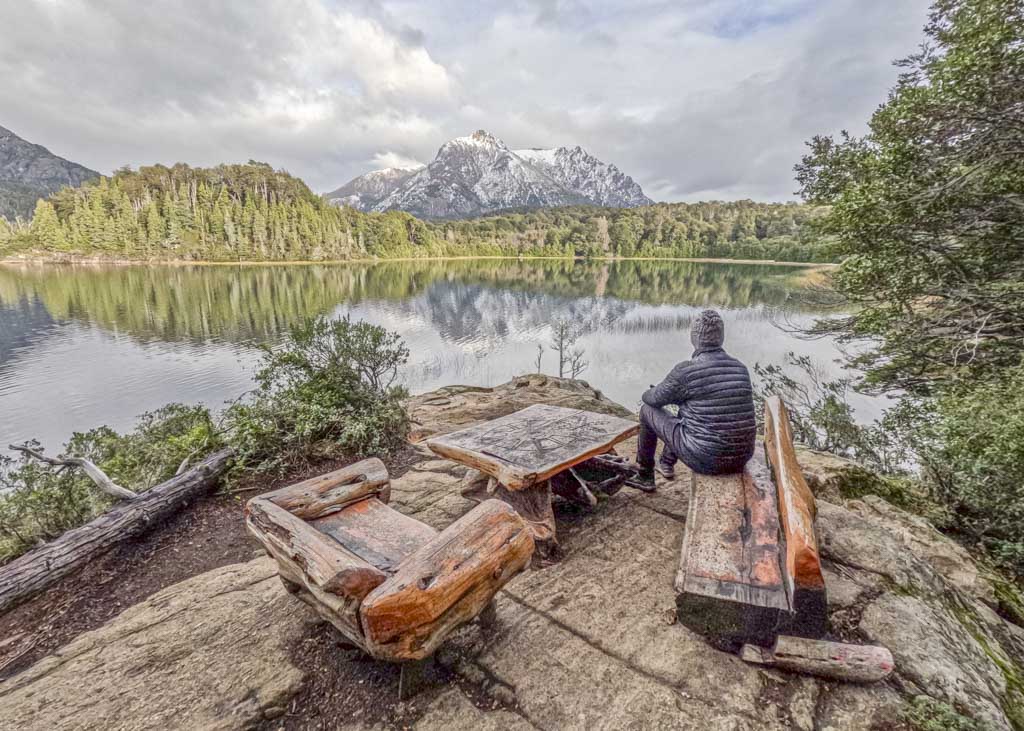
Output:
(0, 558), (312, 730)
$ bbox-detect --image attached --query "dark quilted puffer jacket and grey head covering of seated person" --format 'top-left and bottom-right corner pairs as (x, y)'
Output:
(643, 311), (758, 474)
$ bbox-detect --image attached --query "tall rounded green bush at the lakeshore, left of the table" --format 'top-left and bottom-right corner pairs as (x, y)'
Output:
(224, 316), (409, 472)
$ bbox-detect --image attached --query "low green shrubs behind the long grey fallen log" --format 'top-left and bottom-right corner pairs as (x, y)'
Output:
(0, 403), (219, 563)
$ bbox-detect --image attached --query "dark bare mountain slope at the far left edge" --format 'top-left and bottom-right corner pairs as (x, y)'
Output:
(0, 126), (99, 220)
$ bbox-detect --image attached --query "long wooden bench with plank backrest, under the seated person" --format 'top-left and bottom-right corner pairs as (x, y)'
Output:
(676, 396), (827, 649)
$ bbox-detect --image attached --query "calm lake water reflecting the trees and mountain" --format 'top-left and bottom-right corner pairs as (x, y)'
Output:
(0, 260), (876, 448)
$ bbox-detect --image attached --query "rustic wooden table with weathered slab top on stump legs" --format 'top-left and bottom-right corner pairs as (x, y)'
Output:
(427, 403), (640, 549)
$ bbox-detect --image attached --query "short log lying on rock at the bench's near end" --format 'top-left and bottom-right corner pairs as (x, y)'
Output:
(739, 635), (893, 683)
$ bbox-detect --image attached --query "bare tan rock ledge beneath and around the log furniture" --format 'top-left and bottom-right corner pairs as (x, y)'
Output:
(0, 376), (1024, 731)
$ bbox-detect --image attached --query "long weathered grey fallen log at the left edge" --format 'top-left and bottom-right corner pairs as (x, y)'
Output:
(0, 449), (233, 612)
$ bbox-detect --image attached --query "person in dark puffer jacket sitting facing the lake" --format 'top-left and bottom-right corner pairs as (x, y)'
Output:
(636, 309), (757, 488)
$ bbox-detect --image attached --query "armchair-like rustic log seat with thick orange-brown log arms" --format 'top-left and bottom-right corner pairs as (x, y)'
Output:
(246, 459), (534, 661)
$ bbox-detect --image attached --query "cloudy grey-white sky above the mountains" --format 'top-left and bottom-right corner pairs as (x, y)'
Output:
(0, 0), (928, 201)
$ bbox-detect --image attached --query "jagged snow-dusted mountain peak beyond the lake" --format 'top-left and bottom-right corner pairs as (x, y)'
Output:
(327, 130), (652, 218)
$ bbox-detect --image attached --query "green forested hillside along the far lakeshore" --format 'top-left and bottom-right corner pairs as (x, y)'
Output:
(0, 162), (829, 261)
